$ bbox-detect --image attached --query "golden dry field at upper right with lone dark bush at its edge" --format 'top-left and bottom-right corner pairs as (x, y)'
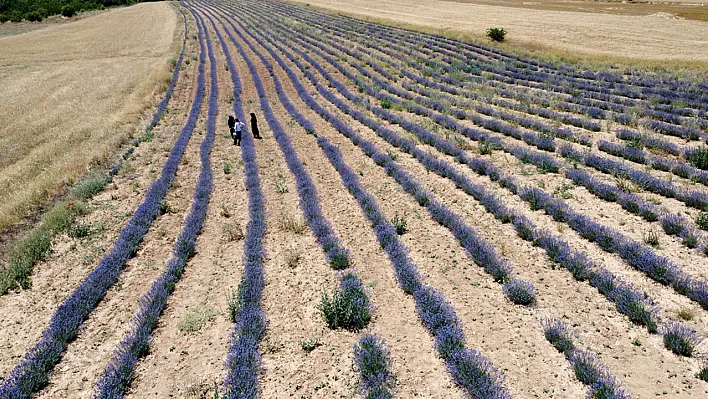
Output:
(292, 0), (708, 71)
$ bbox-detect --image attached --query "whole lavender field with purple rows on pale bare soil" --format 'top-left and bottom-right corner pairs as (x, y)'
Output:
(0, 0), (708, 399)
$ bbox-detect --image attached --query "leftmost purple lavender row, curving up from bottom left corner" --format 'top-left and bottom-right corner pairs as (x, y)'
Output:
(0, 4), (205, 399)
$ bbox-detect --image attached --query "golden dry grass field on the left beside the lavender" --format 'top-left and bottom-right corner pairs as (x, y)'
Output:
(0, 3), (177, 230)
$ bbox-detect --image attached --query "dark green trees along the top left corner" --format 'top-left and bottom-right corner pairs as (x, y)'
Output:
(0, 0), (157, 23)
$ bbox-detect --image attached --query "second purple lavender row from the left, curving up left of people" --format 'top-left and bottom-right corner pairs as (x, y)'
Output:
(94, 10), (219, 399)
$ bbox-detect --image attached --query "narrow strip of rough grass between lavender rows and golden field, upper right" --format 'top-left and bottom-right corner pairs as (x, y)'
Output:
(280, 0), (708, 75)
